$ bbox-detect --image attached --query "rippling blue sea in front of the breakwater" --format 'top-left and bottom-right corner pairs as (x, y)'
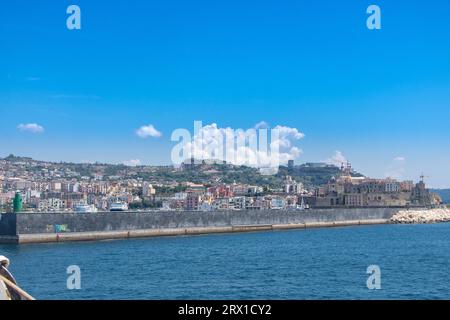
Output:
(0, 223), (450, 299)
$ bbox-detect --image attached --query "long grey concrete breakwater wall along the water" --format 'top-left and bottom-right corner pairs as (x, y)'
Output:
(0, 207), (401, 243)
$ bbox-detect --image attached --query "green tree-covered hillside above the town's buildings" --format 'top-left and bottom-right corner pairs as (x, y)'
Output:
(0, 155), (362, 190)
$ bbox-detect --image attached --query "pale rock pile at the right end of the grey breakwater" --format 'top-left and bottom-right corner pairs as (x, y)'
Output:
(391, 208), (450, 223)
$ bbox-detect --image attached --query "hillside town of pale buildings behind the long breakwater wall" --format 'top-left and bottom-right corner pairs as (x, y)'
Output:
(0, 156), (441, 212)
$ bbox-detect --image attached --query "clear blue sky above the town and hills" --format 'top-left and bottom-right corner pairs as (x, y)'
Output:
(0, 0), (450, 187)
